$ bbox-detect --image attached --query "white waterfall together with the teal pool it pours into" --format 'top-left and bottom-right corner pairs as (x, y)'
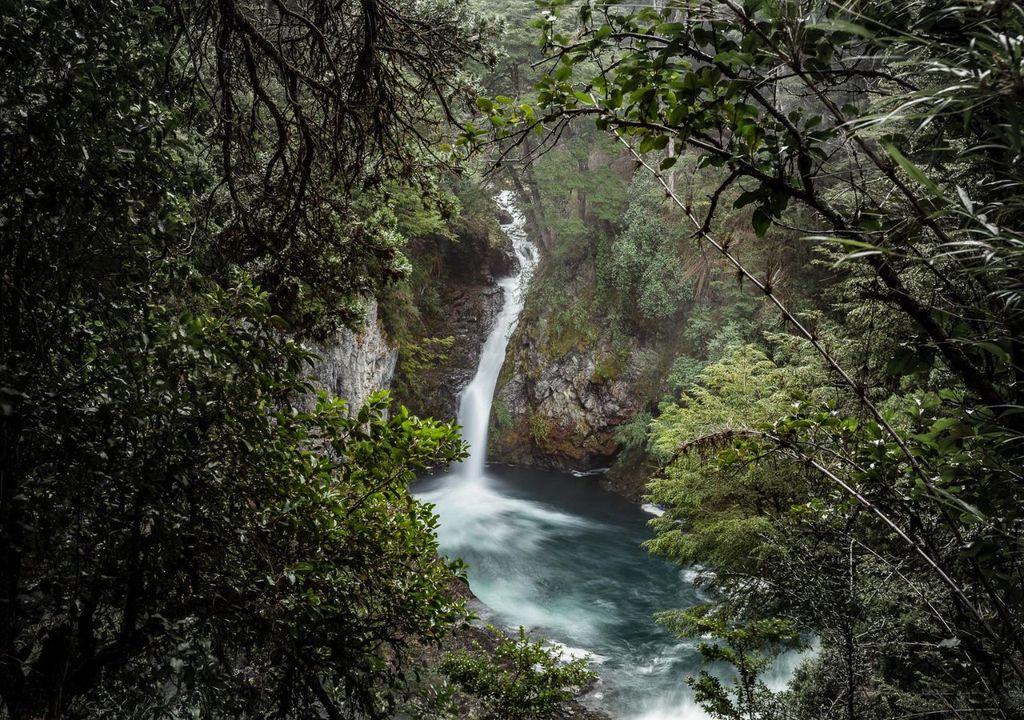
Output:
(416, 193), (793, 720)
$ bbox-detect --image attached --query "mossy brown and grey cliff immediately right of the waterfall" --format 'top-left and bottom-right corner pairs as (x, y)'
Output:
(489, 173), (684, 496)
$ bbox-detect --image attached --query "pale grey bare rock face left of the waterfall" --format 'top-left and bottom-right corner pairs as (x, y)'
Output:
(312, 300), (398, 412)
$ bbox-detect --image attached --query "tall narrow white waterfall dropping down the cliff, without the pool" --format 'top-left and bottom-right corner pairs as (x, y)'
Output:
(458, 190), (537, 478)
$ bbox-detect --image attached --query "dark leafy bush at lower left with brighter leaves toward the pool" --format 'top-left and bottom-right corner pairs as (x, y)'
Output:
(4, 272), (464, 718)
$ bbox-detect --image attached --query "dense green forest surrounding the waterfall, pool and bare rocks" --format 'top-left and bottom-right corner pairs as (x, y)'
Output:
(0, 0), (1024, 720)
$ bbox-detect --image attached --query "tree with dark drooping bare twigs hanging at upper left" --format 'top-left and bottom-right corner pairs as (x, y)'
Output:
(187, 0), (490, 330)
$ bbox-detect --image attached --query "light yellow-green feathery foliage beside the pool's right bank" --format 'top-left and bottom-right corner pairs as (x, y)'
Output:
(648, 346), (820, 582)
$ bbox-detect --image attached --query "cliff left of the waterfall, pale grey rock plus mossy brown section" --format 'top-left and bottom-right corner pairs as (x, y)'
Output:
(299, 191), (514, 420)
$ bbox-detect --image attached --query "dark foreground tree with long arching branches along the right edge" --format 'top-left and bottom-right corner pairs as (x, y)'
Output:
(475, 0), (1024, 717)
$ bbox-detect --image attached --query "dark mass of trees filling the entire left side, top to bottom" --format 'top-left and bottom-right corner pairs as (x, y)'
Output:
(0, 0), (480, 720)
